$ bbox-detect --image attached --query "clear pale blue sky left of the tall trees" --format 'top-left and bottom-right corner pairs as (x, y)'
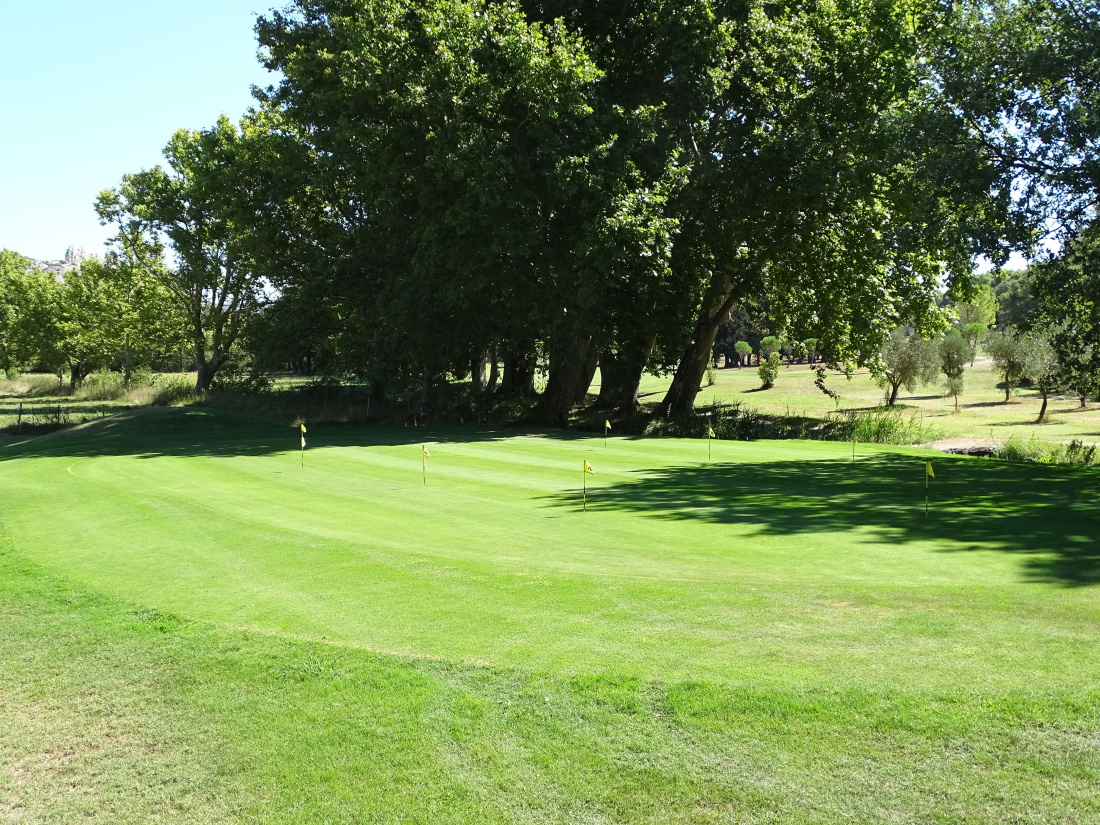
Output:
(0, 0), (275, 260)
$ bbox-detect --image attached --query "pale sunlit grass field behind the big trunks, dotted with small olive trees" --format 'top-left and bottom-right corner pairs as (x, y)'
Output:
(629, 355), (1100, 443)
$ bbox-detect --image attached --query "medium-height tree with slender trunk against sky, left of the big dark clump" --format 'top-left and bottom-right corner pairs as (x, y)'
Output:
(96, 117), (275, 393)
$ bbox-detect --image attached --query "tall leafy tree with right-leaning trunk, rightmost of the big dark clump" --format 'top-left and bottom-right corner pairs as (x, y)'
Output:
(661, 3), (1011, 413)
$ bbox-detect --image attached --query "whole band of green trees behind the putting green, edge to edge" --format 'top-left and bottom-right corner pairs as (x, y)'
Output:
(0, 0), (1100, 426)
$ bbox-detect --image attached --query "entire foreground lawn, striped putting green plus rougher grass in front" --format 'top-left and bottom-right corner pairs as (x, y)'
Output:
(0, 408), (1100, 823)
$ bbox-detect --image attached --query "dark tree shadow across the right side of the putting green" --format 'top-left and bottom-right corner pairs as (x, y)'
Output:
(551, 454), (1100, 585)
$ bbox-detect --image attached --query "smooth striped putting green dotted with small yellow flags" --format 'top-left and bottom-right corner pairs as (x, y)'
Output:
(0, 409), (1100, 692)
